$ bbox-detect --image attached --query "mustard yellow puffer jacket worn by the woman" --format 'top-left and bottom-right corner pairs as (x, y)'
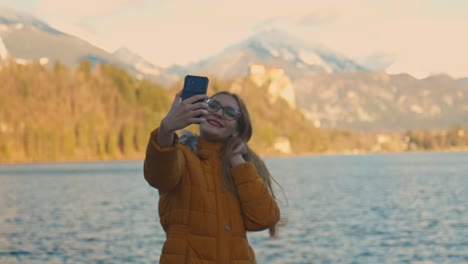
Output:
(144, 130), (280, 264)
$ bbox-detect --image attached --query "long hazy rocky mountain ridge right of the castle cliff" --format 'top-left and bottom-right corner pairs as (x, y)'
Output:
(294, 72), (468, 131)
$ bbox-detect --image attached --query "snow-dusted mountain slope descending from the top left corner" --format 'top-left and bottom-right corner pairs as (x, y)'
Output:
(0, 7), (176, 85)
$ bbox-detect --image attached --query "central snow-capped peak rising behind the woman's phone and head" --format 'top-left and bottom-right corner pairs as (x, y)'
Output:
(172, 30), (366, 80)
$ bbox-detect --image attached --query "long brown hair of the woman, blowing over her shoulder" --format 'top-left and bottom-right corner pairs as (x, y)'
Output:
(212, 91), (286, 237)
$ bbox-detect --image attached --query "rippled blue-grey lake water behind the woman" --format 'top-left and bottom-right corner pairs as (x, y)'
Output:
(0, 153), (468, 264)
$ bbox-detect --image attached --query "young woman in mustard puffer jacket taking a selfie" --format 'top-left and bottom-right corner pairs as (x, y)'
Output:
(144, 92), (280, 264)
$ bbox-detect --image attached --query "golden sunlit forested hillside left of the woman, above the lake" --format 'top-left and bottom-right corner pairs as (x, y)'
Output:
(0, 61), (170, 161)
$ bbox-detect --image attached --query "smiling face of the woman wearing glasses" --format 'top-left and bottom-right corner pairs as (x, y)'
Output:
(200, 94), (239, 141)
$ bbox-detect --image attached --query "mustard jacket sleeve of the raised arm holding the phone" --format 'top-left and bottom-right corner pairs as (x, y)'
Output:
(143, 129), (185, 192)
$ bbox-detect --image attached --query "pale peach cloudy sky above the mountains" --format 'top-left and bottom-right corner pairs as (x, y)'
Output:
(0, 0), (468, 78)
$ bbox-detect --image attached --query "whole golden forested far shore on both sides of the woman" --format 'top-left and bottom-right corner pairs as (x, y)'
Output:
(0, 61), (468, 163)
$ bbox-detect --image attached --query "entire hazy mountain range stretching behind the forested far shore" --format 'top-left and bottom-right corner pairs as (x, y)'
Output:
(0, 8), (468, 130)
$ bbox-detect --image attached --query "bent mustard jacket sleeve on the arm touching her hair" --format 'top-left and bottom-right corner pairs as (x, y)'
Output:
(231, 162), (280, 231)
